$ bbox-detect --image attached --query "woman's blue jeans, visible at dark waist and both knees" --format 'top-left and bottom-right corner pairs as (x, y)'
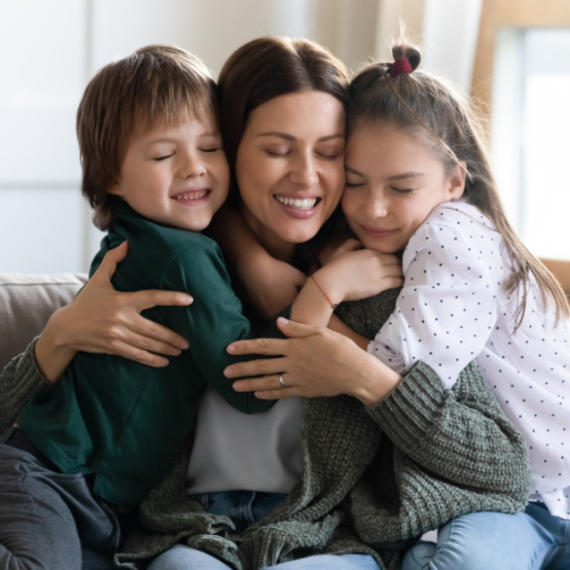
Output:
(147, 491), (379, 570)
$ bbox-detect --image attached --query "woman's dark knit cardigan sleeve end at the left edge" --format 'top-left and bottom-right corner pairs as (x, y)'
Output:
(0, 339), (52, 434)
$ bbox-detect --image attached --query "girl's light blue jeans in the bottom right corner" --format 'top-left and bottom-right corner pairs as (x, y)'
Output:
(402, 503), (570, 570)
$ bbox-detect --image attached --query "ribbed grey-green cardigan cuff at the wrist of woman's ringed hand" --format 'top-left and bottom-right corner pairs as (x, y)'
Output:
(367, 361), (451, 449)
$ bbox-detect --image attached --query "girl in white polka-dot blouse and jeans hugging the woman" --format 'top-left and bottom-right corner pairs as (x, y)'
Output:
(282, 42), (570, 570)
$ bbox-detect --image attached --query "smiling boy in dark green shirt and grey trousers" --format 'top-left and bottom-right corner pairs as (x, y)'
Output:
(0, 45), (272, 568)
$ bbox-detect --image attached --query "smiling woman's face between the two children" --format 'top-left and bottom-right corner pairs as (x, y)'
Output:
(236, 91), (345, 259)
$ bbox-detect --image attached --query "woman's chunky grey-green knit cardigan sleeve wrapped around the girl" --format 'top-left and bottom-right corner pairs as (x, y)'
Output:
(367, 361), (530, 498)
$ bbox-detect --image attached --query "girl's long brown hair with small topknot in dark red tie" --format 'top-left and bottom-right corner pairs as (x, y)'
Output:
(348, 43), (570, 328)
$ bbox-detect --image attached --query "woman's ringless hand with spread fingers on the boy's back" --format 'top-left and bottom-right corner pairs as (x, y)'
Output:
(35, 242), (192, 381)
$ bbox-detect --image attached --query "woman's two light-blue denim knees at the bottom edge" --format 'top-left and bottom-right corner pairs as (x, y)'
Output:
(147, 544), (380, 570)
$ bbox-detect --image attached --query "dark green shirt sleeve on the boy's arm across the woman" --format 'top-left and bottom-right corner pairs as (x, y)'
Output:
(162, 238), (280, 413)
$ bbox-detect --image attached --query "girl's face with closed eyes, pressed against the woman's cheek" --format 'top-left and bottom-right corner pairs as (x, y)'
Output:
(342, 122), (465, 253)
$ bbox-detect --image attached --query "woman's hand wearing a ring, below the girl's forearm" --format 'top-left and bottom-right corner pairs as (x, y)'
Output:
(225, 317), (402, 405)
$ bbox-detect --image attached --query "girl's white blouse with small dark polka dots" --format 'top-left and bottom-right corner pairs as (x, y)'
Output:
(368, 202), (570, 519)
